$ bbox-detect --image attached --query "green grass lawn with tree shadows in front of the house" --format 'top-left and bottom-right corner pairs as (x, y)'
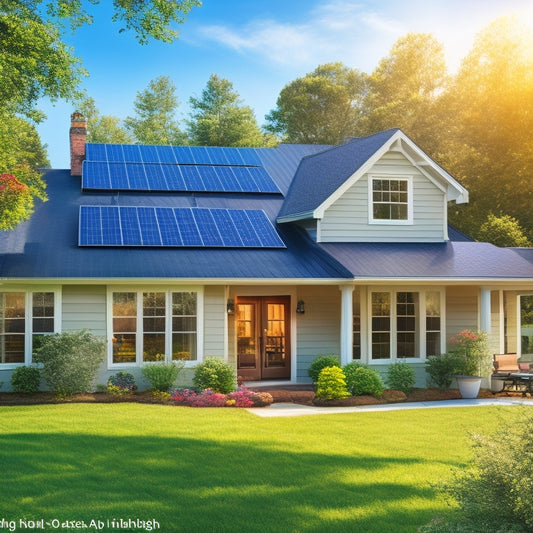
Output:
(0, 403), (517, 533)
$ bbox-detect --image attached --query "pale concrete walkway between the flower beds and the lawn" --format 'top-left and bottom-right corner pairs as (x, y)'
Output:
(248, 398), (533, 418)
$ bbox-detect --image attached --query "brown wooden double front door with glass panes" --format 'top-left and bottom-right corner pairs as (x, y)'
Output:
(235, 296), (291, 380)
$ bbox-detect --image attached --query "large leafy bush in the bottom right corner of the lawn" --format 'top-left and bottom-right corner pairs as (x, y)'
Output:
(421, 408), (533, 533)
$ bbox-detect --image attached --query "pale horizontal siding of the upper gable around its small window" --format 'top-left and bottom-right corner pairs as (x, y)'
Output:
(319, 152), (446, 242)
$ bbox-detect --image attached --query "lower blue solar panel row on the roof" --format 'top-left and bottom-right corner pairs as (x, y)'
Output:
(78, 205), (285, 248)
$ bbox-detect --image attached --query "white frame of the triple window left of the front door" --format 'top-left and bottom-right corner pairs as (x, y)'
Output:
(106, 286), (204, 369)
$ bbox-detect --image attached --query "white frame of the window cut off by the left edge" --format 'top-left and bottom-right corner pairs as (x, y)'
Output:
(0, 286), (61, 370)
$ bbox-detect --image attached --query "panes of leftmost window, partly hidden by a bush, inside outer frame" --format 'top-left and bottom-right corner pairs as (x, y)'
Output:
(0, 291), (56, 365)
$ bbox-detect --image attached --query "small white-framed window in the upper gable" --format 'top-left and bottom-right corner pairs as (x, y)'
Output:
(369, 176), (413, 224)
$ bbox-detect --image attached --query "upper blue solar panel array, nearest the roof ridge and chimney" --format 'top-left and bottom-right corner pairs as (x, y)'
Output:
(82, 143), (280, 194)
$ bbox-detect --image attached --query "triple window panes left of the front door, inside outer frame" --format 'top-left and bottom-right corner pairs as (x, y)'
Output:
(111, 291), (198, 364)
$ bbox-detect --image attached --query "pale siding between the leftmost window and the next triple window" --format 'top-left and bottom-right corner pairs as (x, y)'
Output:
(61, 285), (107, 337)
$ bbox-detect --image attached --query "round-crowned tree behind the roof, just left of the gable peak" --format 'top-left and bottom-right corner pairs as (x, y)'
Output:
(265, 63), (366, 144)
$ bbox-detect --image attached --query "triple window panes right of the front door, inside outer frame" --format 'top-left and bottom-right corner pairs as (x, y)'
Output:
(369, 290), (444, 361)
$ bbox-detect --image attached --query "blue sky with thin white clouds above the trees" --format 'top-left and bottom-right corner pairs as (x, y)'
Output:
(38, 0), (533, 168)
